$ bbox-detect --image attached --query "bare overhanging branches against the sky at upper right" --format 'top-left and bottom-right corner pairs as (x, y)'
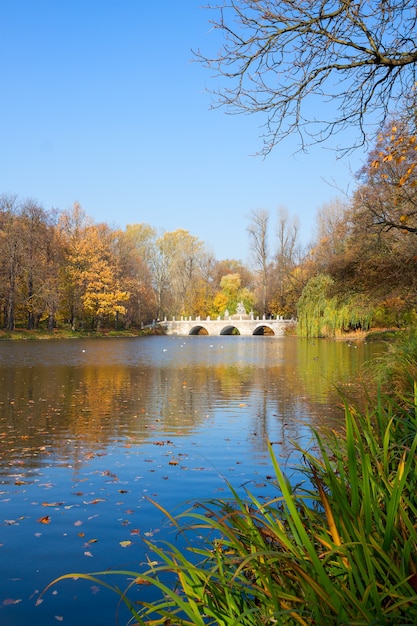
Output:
(196, 0), (417, 154)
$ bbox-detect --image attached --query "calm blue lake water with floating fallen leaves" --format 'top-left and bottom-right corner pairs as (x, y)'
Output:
(0, 337), (381, 626)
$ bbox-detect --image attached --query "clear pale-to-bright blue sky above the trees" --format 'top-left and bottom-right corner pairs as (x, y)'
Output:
(0, 0), (363, 262)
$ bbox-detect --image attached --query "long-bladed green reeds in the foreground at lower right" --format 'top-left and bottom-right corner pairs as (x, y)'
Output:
(41, 396), (417, 626)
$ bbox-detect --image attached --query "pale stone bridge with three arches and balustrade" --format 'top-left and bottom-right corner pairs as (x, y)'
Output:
(159, 315), (296, 337)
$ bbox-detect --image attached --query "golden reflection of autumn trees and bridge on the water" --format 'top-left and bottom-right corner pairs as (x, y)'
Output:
(0, 337), (376, 471)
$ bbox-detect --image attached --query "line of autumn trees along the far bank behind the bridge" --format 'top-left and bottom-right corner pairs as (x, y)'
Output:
(0, 111), (417, 336)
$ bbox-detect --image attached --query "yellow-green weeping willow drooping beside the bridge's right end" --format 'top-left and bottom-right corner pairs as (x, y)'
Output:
(297, 274), (372, 337)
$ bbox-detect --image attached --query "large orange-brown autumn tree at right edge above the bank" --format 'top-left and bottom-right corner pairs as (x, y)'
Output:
(308, 119), (417, 325)
